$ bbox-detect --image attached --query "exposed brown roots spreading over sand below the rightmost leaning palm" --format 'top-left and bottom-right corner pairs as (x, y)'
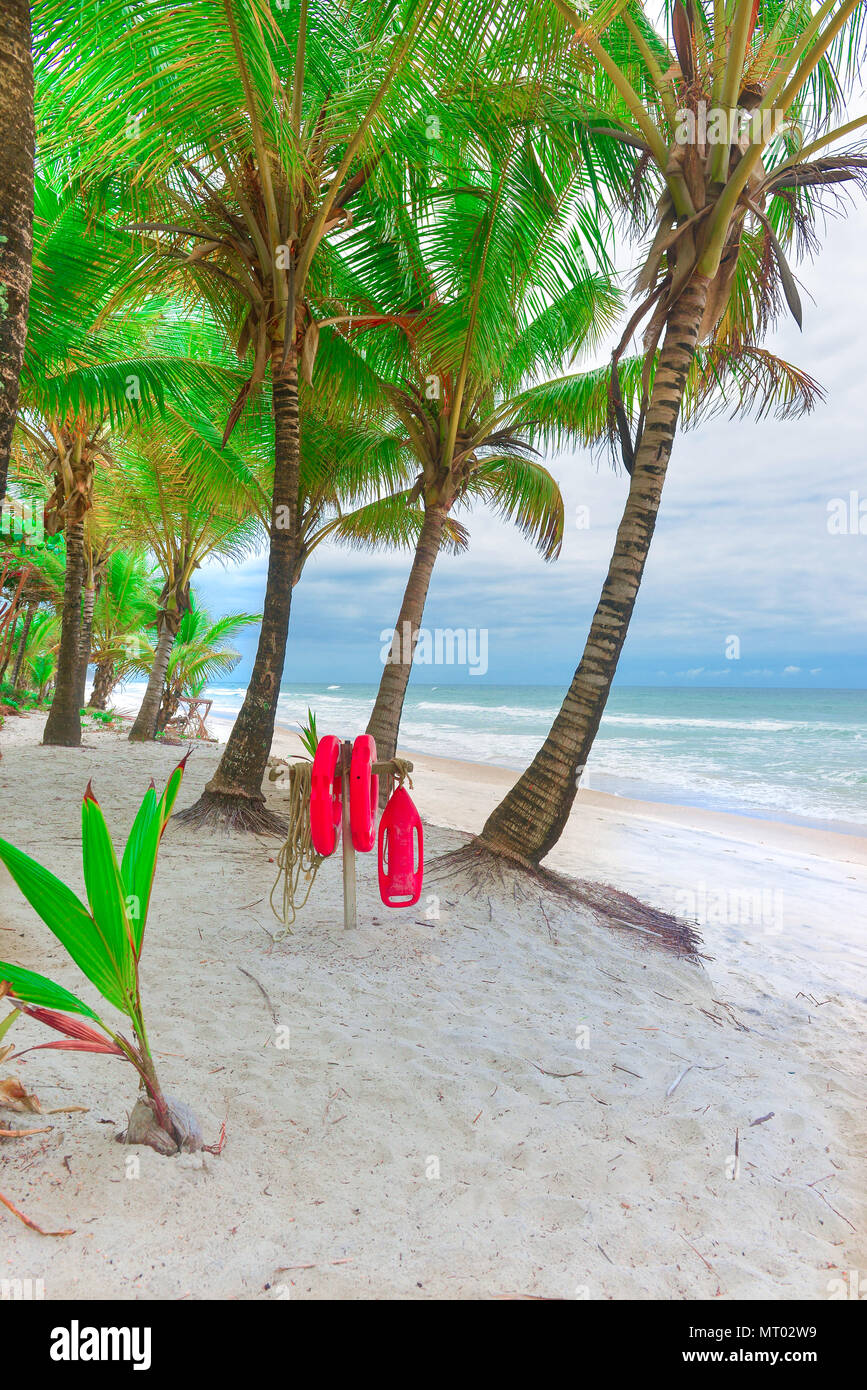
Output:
(425, 840), (707, 960)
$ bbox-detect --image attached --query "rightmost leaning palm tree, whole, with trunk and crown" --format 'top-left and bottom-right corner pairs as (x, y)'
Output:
(481, 0), (867, 865)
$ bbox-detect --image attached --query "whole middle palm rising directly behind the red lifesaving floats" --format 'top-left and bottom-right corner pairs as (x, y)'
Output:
(337, 113), (618, 767)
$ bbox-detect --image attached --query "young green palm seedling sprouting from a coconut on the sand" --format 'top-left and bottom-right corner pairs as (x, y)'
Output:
(0, 758), (201, 1154)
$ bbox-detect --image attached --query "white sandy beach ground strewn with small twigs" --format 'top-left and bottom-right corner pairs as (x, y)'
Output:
(0, 716), (867, 1298)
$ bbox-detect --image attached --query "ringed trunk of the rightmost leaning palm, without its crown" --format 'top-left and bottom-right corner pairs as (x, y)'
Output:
(479, 275), (710, 865)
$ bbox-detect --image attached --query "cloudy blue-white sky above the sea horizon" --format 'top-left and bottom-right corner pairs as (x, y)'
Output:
(199, 195), (867, 688)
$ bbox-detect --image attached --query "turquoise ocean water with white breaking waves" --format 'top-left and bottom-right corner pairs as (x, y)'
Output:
(116, 684), (867, 833)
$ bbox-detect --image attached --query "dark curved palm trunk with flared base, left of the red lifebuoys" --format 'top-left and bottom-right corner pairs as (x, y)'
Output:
(179, 353), (300, 833)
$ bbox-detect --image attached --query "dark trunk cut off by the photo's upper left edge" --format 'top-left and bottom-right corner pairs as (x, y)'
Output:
(0, 0), (33, 502)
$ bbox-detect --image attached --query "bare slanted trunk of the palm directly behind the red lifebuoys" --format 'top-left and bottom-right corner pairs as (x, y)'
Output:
(367, 507), (447, 798)
